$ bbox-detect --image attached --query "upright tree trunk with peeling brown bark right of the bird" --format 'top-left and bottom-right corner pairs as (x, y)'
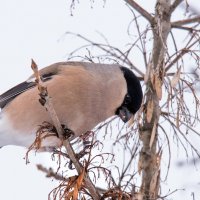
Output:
(139, 0), (171, 200)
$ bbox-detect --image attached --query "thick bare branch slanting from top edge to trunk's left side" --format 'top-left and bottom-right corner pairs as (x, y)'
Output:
(125, 0), (154, 24)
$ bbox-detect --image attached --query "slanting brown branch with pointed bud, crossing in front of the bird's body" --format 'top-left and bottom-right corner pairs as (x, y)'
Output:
(31, 60), (100, 200)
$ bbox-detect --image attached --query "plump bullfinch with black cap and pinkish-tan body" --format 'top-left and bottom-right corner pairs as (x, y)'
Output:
(0, 61), (143, 151)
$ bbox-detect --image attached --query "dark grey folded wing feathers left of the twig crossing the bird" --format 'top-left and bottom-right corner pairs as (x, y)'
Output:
(0, 81), (36, 109)
